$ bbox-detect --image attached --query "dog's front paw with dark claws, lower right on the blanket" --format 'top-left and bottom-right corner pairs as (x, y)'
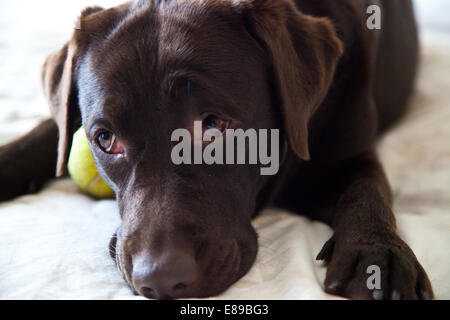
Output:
(317, 233), (433, 300)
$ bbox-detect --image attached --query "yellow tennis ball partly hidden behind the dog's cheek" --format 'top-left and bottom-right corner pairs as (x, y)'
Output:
(67, 127), (114, 199)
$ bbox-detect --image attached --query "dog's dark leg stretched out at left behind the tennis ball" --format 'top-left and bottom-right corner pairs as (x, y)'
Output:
(0, 119), (58, 201)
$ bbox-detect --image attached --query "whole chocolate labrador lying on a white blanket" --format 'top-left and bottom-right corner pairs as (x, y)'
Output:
(0, 0), (433, 299)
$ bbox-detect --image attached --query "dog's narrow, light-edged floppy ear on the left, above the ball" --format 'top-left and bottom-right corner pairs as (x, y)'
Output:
(41, 7), (103, 176)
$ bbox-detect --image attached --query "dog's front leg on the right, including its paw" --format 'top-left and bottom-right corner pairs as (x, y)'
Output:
(308, 152), (433, 299)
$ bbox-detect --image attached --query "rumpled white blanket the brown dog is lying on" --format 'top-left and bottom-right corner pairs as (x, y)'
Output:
(0, 0), (450, 299)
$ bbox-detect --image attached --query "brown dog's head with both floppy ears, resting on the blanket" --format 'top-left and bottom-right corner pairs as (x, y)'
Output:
(43, 0), (342, 298)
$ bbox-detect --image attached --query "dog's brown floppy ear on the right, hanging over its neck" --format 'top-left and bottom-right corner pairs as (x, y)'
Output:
(238, 0), (343, 160)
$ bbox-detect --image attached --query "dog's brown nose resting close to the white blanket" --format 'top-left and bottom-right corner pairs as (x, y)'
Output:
(132, 252), (198, 299)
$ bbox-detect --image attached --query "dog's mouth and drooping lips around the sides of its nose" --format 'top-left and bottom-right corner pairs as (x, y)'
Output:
(109, 234), (256, 299)
